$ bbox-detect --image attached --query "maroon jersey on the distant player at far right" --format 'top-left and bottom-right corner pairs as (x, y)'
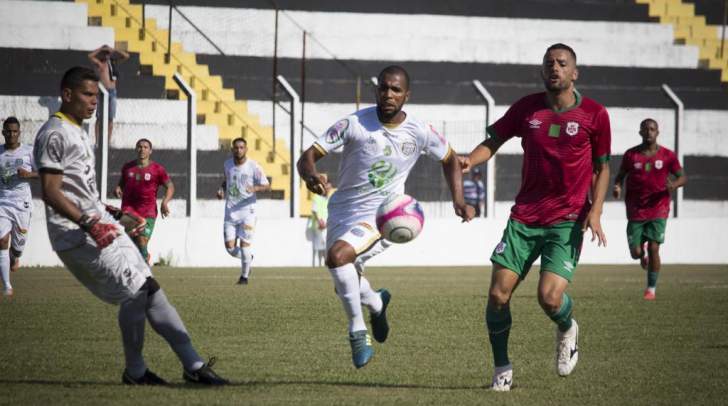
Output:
(622, 145), (682, 221)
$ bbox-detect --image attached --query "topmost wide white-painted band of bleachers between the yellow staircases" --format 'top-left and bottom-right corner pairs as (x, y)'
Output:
(146, 6), (698, 68)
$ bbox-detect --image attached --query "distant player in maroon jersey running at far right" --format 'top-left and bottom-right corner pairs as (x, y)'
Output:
(612, 118), (687, 300)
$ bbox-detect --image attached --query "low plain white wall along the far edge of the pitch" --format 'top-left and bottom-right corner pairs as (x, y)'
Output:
(22, 211), (728, 267)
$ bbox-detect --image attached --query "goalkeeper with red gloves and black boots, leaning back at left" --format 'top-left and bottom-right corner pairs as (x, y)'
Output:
(33, 67), (227, 385)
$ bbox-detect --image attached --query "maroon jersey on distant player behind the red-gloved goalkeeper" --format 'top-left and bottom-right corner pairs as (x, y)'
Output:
(119, 161), (169, 218)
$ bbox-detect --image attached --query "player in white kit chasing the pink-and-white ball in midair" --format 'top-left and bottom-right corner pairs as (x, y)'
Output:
(297, 66), (474, 368)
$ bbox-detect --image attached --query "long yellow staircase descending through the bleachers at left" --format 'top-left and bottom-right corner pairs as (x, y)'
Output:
(76, 0), (289, 200)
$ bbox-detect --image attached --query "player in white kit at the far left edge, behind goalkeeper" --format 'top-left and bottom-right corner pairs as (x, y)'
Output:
(0, 117), (38, 296)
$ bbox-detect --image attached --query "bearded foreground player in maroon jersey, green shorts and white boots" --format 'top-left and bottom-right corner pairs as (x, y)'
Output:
(463, 44), (611, 391)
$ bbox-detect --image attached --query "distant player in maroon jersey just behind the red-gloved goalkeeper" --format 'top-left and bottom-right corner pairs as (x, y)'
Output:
(114, 138), (174, 264)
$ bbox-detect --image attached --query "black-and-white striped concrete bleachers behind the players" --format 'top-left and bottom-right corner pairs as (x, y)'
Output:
(0, 0), (728, 214)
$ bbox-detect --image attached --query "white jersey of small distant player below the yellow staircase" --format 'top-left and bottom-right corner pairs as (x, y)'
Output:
(224, 158), (269, 221)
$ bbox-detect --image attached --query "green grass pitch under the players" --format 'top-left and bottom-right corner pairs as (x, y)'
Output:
(0, 266), (728, 405)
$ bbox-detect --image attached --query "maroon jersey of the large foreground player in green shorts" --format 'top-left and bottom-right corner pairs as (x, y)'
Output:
(488, 91), (612, 226)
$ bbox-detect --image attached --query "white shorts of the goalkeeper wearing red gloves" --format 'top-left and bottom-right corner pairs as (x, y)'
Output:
(57, 234), (152, 304)
